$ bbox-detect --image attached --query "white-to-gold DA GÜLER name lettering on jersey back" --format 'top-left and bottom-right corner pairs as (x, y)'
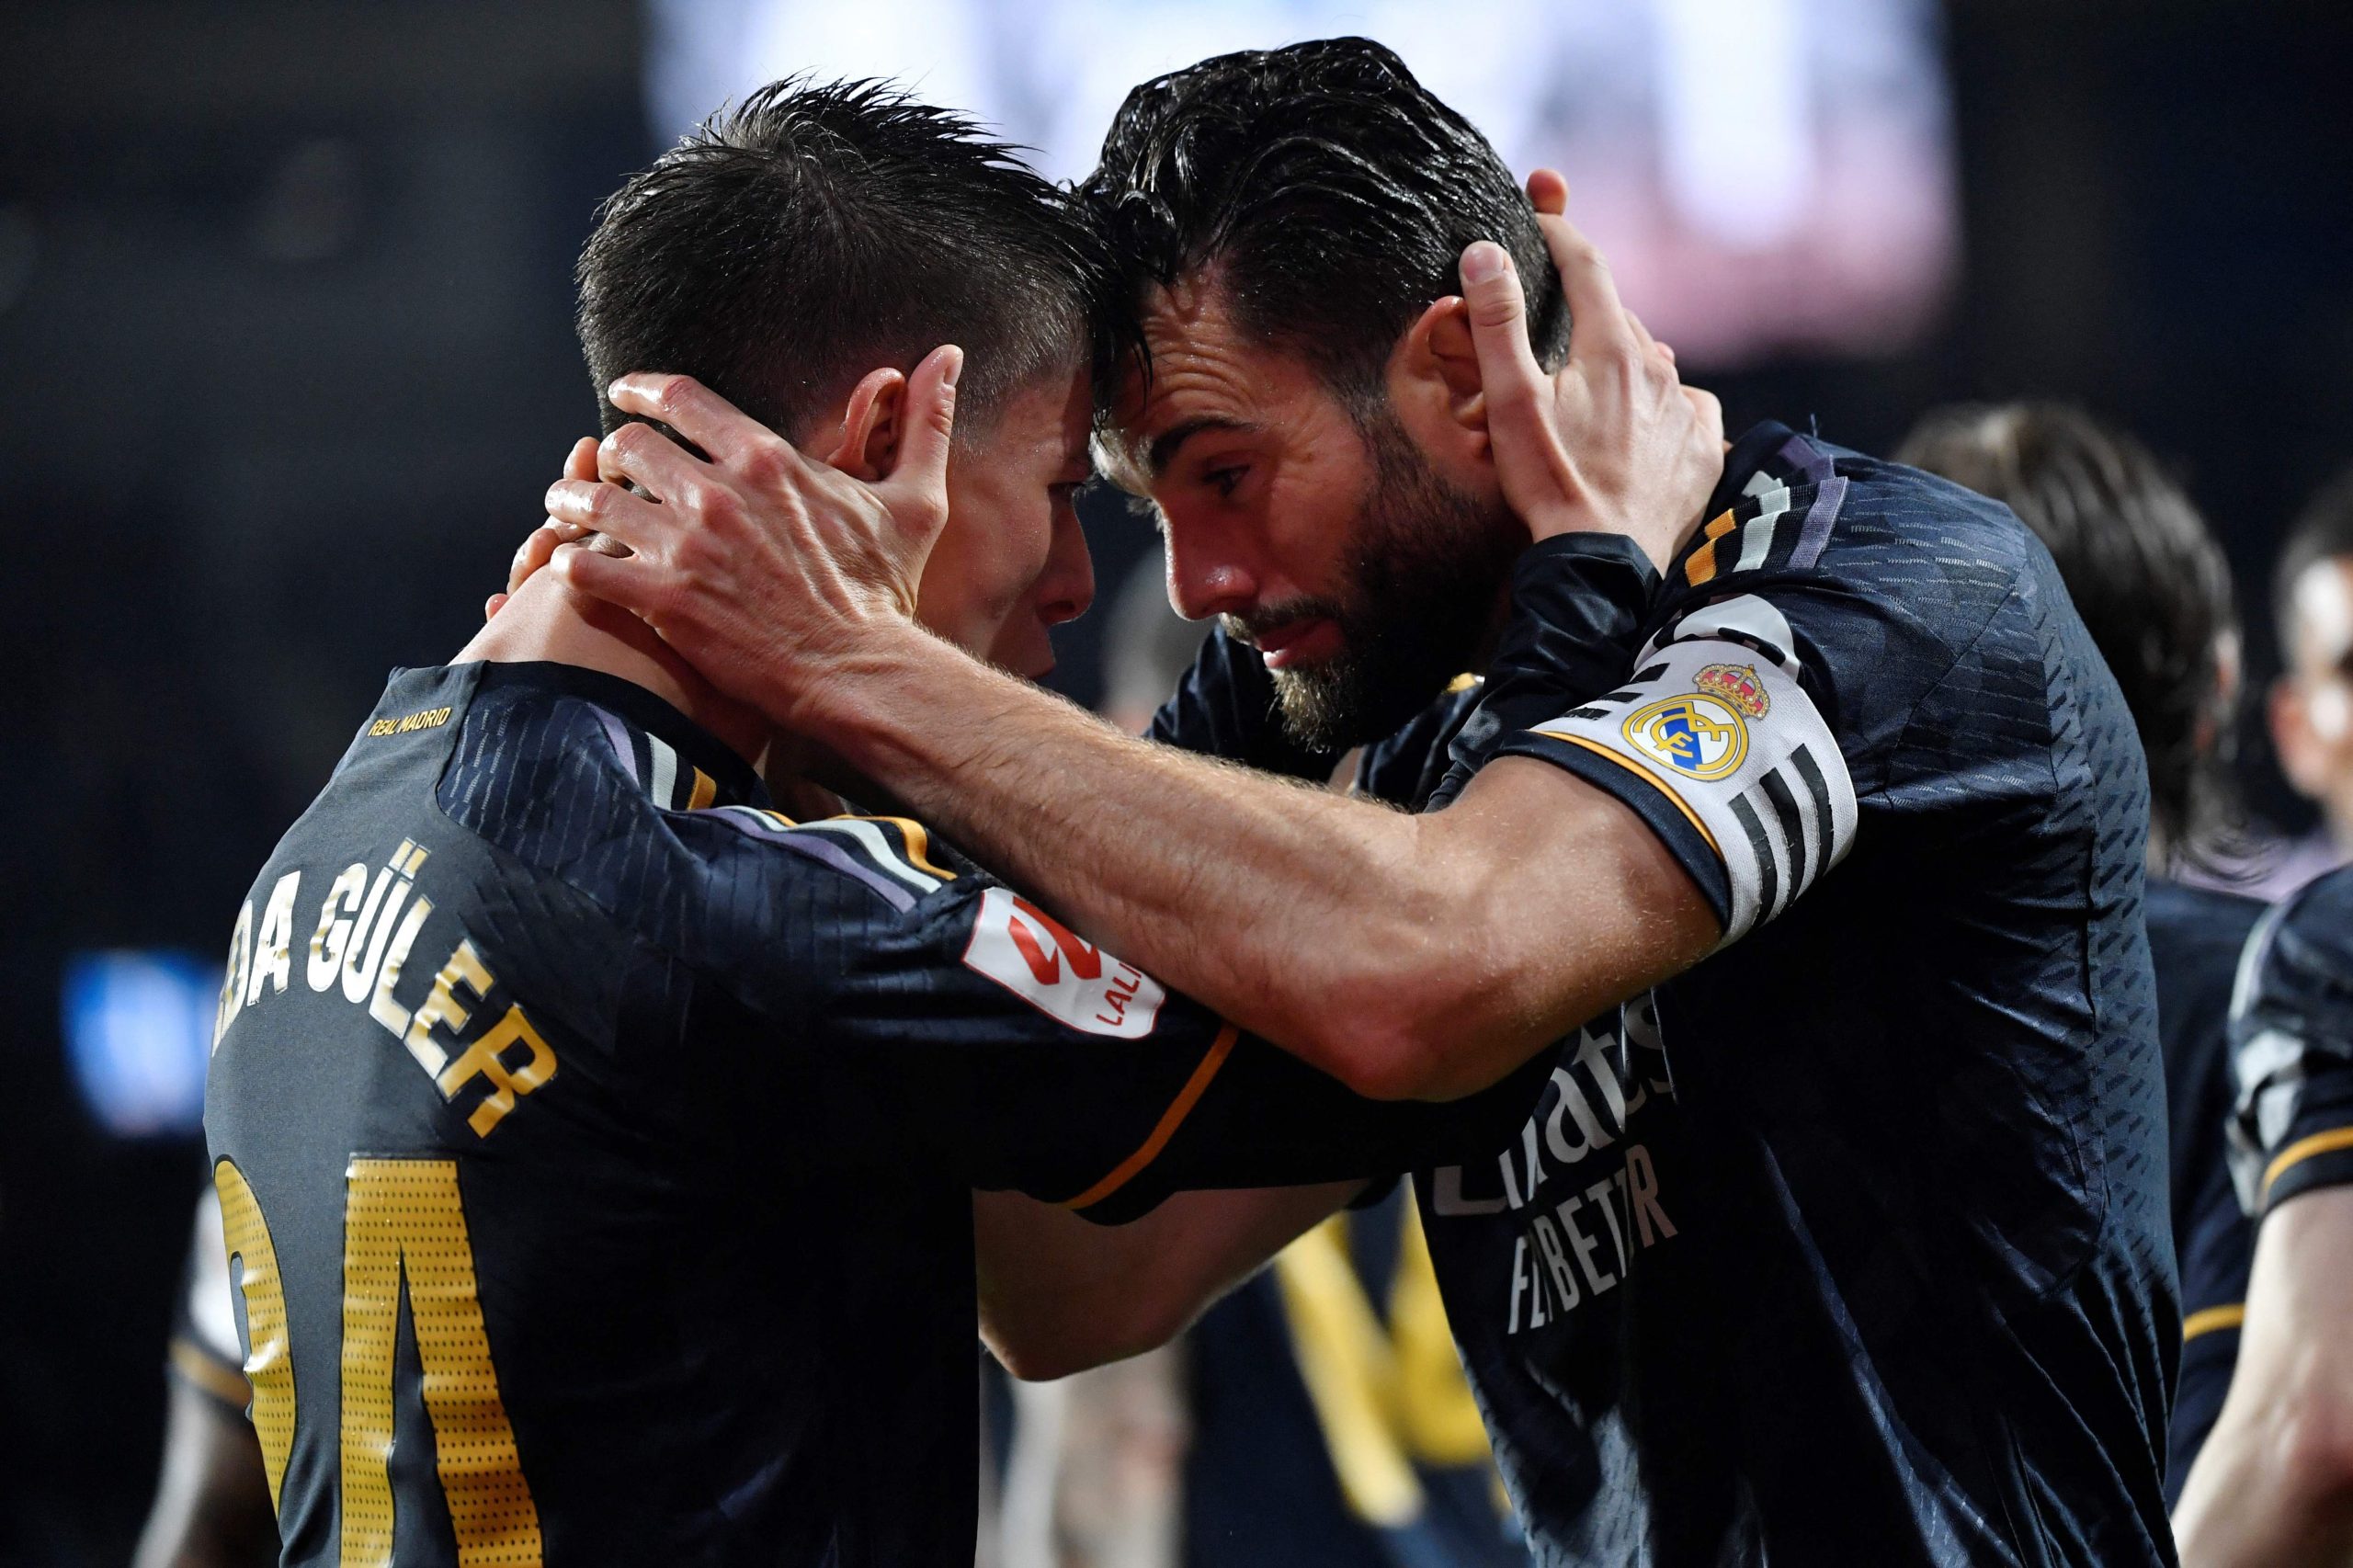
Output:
(211, 838), (555, 1137)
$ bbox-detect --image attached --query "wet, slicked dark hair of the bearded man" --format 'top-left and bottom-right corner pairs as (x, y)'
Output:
(1077, 38), (1570, 405)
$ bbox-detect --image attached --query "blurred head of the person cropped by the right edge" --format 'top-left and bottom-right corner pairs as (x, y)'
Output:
(2270, 471), (2353, 890)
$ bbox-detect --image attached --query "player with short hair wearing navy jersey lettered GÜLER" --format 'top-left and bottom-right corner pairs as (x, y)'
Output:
(205, 83), (1534, 1568)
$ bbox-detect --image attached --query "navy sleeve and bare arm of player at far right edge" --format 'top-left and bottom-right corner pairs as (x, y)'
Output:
(2174, 869), (2353, 1568)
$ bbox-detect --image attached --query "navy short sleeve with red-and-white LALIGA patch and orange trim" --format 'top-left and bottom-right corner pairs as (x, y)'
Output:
(753, 824), (1543, 1221)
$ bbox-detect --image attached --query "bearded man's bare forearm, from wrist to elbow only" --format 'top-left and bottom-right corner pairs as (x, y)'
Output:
(810, 631), (1477, 1093)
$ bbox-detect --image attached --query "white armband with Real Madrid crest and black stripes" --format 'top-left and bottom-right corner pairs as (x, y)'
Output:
(1537, 638), (1857, 942)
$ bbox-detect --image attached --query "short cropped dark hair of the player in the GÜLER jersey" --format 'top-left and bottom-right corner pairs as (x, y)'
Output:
(579, 78), (1092, 436)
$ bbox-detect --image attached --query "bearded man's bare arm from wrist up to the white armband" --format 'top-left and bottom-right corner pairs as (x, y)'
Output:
(790, 633), (1720, 1099)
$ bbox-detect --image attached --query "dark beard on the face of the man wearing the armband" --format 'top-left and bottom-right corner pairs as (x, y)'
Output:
(1223, 407), (1527, 751)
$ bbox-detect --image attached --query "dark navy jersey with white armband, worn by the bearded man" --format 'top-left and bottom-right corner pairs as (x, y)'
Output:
(1157, 426), (2181, 1565)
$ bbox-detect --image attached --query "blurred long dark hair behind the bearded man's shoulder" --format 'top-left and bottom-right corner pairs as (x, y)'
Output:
(1896, 403), (2240, 862)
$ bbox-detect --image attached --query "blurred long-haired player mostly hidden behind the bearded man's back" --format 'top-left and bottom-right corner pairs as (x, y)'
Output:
(1896, 403), (2264, 1505)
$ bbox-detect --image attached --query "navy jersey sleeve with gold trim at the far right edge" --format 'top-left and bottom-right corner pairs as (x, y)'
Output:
(2231, 867), (2353, 1221)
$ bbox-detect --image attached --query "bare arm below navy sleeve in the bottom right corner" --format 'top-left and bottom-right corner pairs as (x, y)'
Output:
(2174, 1187), (2353, 1568)
